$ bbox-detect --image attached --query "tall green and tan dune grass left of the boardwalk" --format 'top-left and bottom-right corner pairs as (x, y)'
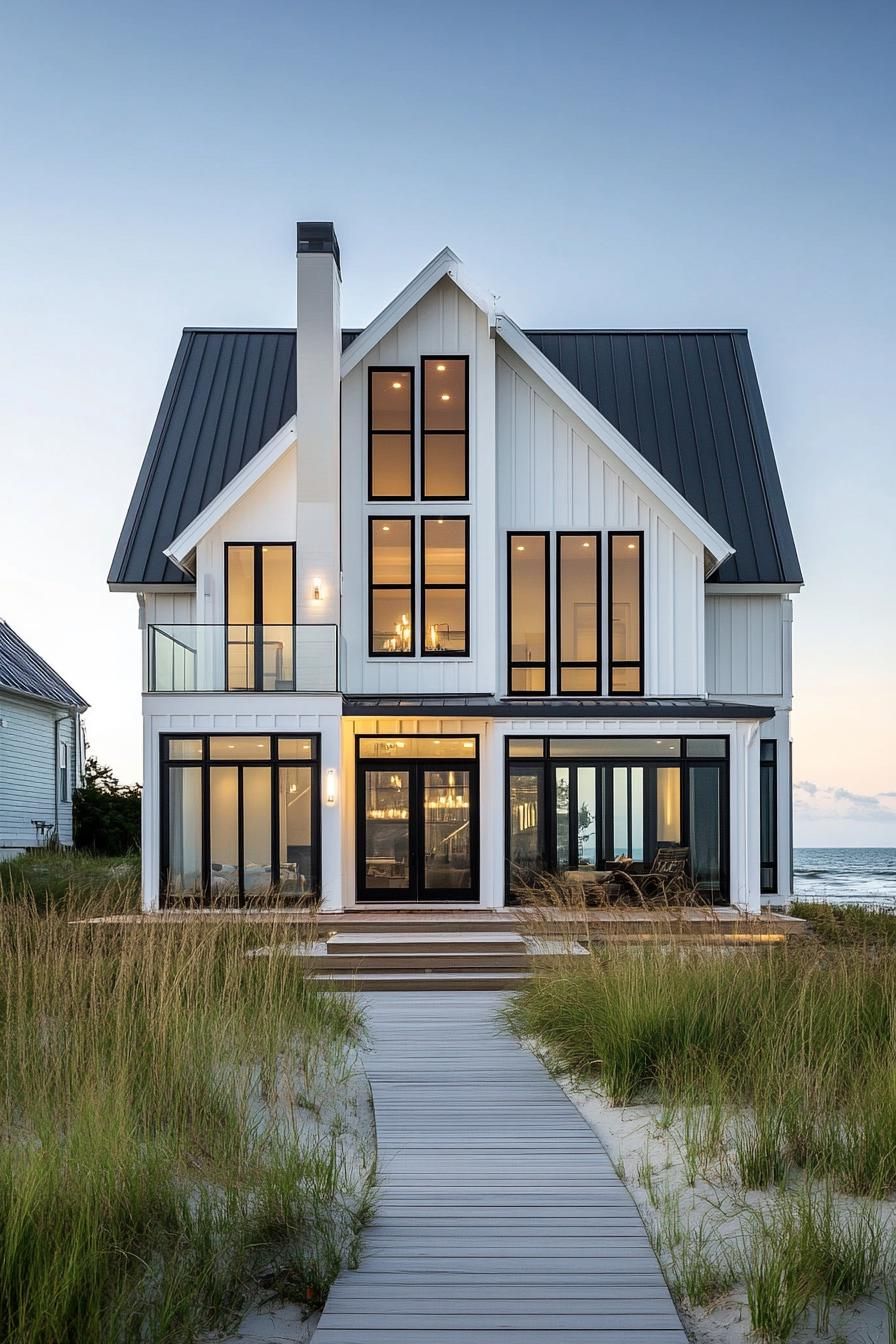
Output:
(0, 879), (372, 1344)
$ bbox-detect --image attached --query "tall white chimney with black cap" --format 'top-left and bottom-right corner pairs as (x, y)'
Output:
(296, 222), (343, 639)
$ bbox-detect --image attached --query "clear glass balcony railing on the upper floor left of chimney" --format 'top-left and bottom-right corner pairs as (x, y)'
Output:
(145, 625), (339, 695)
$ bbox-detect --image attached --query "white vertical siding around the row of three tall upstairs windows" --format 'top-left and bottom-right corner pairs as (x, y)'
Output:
(496, 339), (705, 696)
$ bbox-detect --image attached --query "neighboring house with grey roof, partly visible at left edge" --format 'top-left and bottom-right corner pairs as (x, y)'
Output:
(0, 621), (87, 859)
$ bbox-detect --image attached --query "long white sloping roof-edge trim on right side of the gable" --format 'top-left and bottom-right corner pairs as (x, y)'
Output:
(497, 313), (735, 578)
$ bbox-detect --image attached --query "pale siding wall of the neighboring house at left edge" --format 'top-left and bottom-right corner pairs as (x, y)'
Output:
(0, 695), (81, 857)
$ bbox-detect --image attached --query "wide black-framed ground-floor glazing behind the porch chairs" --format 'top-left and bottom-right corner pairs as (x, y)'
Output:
(505, 738), (728, 900)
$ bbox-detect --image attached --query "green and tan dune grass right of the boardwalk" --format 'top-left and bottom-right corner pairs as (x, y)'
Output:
(506, 941), (896, 1341)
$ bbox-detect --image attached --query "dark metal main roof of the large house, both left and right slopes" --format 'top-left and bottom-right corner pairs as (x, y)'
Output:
(109, 319), (802, 587)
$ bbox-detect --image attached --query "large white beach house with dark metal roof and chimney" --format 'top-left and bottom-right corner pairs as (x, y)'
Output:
(109, 223), (802, 910)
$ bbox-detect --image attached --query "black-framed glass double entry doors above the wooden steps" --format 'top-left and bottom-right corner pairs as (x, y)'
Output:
(357, 758), (478, 905)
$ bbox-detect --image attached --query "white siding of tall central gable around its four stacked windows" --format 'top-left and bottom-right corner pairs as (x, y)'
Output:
(341, 277), (497, 695)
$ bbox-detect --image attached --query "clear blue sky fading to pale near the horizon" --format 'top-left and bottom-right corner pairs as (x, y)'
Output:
(0, 0), (896, 844)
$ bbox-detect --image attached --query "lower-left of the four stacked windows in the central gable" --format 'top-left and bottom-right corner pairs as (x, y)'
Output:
(367, 517), (415, 659)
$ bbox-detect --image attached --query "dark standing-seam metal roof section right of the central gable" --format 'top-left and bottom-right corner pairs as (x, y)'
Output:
(527, 331), (802, 583)
